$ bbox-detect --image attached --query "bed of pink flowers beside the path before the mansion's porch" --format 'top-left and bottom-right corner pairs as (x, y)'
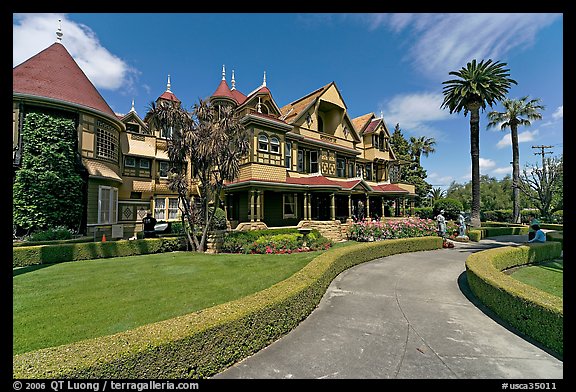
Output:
(347, 218), (458, 242)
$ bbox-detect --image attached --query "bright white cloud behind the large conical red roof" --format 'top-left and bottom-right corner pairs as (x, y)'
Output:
(12, 14), (138, 92)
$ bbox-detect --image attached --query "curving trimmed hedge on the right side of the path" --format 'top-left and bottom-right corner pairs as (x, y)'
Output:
(466, 242), (564, 356)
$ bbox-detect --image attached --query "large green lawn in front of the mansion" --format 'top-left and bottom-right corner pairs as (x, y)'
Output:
(13, 250), (328, 354)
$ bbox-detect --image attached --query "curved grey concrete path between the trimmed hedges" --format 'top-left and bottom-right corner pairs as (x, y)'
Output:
(213, 235), (563, 379)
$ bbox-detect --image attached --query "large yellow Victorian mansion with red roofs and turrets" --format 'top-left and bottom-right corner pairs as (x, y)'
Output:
(13, 30), (416, 239)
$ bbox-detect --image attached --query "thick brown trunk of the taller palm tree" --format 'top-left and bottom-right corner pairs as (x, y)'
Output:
(468, 103), (481, 228)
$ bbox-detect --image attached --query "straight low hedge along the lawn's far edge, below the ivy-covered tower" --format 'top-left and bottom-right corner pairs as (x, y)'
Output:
(12, 237), (186, 267)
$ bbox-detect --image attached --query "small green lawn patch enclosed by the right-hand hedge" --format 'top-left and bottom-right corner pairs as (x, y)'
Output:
(510, 259), (564, 298)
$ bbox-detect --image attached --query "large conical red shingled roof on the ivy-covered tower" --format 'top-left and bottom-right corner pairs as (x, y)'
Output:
(12, 43), (115, 116)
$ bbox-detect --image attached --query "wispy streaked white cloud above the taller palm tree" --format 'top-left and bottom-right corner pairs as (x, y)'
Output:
(358, 13), (562, 78)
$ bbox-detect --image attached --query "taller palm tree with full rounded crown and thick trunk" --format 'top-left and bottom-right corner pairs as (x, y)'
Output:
(441, 59), (518, 227)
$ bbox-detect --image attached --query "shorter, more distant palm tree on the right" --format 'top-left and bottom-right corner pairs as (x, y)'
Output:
(487, 96), (544, 223)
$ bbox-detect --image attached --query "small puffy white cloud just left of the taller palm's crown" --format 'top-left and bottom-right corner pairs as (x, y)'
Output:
(378, 92), (451, 137)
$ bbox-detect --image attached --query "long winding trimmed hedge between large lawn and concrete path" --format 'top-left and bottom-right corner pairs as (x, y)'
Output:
(13, 237), (442, 379)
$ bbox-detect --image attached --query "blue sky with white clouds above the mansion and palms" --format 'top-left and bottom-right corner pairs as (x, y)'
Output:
(13, 13), (563, 188)
